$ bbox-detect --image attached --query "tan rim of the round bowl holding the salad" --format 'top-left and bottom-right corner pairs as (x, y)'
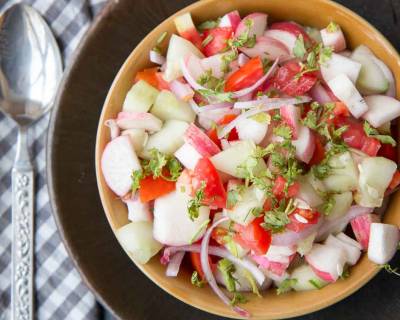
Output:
(95, 0), (400, 319)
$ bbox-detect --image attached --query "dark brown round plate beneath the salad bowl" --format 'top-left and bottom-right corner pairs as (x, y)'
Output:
(48, 0), (400, 320)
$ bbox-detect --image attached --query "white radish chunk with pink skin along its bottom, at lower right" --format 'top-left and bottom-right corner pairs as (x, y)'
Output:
(306, 243), (346, 282)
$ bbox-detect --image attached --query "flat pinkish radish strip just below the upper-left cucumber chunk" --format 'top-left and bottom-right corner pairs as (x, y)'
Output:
(117, 111), (162, 132)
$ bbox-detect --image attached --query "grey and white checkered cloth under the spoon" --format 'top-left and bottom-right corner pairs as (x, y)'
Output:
(0, 0), (106, 320)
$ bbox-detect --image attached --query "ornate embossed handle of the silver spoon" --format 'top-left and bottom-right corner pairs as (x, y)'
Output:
(11, 129), (34, 320)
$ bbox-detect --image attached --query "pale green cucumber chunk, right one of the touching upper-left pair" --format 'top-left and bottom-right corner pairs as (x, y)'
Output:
(150, 90), (196, 122)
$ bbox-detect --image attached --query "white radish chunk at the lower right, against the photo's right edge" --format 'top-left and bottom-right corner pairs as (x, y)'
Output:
(368, 223), (400, 264)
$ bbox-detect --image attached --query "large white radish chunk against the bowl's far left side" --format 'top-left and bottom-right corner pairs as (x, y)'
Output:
(101, 136), (141, 197)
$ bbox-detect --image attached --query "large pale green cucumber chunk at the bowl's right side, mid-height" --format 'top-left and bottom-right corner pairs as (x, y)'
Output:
(354, 157), (397, 208)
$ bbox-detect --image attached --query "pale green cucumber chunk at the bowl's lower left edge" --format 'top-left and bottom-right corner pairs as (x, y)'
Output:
(115, 221), (163, 264)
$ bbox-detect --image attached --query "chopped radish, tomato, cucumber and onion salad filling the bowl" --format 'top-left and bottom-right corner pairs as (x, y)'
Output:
(101, 11), (400, 316)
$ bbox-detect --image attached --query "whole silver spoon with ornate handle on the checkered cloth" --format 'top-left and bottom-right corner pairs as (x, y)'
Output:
(0, 4), (62, 320)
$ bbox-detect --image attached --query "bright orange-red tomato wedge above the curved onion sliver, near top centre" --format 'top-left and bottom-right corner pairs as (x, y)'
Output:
(225, 57), (264, 92)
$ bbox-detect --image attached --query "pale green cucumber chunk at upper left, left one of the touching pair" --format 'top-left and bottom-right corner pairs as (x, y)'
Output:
(122, 80), (159, 112)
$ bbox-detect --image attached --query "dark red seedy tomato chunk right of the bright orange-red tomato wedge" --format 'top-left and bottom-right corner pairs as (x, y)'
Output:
(274, 62), (317, 96)
